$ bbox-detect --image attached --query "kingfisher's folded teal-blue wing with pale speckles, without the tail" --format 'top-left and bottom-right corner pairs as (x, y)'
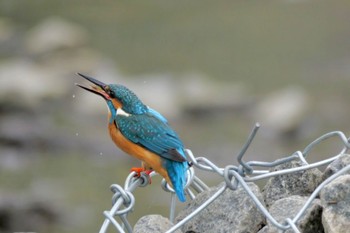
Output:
(115, 113), (186, 162)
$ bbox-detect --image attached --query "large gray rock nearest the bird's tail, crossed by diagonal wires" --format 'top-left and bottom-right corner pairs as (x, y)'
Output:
(176, 183), (265, 233)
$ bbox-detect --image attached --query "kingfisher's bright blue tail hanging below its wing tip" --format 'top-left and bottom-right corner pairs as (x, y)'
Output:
(165, 156), (188, 202)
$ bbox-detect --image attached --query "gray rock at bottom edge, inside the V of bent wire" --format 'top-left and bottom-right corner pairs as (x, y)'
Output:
(264, 196), (323, 233)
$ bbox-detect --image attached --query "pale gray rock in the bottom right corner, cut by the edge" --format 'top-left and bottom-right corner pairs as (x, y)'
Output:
(320, 175), (350, 233)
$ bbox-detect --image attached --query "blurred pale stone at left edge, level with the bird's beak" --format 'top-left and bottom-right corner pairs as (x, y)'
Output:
(0, 58), (73, 107)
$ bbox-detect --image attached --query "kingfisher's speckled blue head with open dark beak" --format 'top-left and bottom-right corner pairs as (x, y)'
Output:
(76, 73), (147, 114)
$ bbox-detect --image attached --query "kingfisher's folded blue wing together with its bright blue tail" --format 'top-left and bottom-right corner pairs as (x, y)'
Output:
(115, 113), (188, 201)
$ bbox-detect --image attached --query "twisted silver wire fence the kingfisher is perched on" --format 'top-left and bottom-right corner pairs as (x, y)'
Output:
(100, 123), (350, 233)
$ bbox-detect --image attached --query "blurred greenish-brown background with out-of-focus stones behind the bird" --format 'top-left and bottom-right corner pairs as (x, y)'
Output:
(0, 0), (350, 232)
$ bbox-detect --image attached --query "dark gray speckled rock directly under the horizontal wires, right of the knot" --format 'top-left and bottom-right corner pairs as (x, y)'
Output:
(263, 161), (322, 206)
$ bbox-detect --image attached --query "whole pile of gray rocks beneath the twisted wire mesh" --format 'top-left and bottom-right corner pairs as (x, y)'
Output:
(134, 154), (350, 233)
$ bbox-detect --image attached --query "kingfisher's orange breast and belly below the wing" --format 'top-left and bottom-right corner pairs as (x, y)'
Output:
(108, 122), (171, 184)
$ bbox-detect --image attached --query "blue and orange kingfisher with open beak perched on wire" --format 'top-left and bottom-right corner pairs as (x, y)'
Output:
(76, 73), (189, 202)
